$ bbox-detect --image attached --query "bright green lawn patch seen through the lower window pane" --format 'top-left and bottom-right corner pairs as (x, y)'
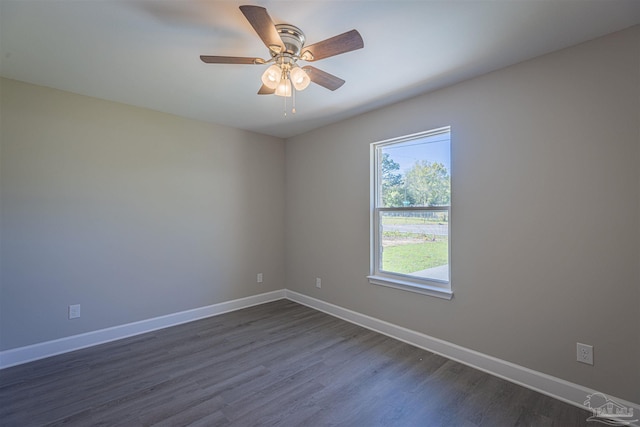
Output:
(382, 240), (449, 274)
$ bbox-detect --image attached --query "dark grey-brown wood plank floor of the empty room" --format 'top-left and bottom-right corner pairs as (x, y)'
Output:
(0, 300), (590, 427)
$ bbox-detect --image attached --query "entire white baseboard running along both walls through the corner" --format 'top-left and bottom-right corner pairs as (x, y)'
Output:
(0, 289), (640, 427)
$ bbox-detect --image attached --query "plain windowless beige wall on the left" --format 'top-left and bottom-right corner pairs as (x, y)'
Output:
(0, 79), (284, 350)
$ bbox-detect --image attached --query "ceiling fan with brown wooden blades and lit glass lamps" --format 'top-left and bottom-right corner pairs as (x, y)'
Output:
(200, 6), (364, 97)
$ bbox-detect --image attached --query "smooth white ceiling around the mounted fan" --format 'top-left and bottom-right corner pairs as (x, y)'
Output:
(0, 0), (640, 138)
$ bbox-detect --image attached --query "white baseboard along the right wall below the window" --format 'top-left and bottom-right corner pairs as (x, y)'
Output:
(285, 290), (640, 426)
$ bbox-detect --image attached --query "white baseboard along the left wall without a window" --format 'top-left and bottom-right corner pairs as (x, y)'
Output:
(0, 289), (285, 369)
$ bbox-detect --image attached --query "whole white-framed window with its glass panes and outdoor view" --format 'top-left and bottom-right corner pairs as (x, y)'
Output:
(369, 127), (453, 299)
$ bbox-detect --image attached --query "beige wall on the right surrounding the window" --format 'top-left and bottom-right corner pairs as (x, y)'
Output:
(285, 27), (640, 402)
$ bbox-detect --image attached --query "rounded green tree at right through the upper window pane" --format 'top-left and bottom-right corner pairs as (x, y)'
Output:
(405, 160), (451, 206)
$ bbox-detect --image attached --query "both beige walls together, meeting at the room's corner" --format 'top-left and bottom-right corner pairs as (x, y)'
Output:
(0, 27), (640, 402)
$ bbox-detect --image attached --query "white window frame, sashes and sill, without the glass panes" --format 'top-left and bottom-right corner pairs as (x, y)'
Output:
(367, 126), (453, 300)
